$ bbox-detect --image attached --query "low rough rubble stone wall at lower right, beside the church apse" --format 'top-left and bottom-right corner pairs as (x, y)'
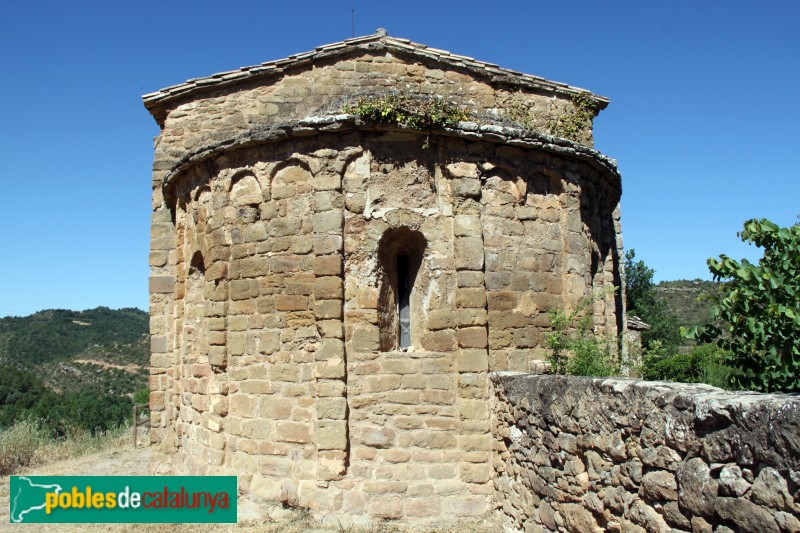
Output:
(492, 374), (800, 533)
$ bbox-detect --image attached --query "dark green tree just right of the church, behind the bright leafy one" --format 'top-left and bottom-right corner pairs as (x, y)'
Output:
(625, 249), (681, 356)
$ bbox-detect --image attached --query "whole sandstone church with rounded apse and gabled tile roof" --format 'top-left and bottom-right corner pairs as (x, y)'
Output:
(144, 32), (624, 522)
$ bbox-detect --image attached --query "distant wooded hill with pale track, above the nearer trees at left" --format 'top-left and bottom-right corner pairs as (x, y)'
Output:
(0, 307), (150, 395)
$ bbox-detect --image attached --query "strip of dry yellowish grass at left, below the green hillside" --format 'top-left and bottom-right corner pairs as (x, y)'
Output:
(0, 420), (130, 476)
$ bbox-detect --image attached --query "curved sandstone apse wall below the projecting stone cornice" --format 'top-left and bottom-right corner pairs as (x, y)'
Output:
(151, 120), (619, 523)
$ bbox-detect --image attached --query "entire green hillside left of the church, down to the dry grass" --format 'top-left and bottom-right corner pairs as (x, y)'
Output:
(0, 307), (149, 440)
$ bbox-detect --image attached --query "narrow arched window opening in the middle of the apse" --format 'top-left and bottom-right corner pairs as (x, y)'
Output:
(378, 228), (427, 351)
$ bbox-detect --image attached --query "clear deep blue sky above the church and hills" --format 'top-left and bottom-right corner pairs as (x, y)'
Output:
(0, 0), (800, 316)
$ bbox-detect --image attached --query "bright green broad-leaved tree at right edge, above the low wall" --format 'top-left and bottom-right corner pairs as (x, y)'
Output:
(689, 219), (800, 392)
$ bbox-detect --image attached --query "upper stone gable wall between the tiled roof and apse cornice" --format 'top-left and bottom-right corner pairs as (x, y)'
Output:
(151, 50), (593, 202)
